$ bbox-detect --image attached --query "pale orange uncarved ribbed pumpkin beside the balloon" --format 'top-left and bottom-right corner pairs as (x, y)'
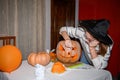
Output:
(28, 52), (50, 66)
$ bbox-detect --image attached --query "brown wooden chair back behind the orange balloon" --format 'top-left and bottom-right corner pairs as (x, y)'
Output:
(0, 36), (16, 46)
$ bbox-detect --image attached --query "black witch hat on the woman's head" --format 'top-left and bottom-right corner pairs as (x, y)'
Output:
(80, 19), (113, 45)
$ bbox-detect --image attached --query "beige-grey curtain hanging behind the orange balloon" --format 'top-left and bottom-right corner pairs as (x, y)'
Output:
(0, 0), (45, 59)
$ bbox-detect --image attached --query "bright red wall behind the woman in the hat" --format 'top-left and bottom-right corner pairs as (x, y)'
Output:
(79, 0), (120, 76)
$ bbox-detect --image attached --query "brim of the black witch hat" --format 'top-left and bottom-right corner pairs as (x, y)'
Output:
(84, 26), (113, 45)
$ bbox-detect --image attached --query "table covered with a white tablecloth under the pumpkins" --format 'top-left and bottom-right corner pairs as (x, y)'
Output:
(0, 60), (112, 80)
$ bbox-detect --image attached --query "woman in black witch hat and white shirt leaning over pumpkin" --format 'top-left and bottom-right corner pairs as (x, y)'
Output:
(60, 19), (113, 69)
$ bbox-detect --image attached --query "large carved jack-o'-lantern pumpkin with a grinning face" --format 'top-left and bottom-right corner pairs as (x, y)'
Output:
(56, 40), (82, 63)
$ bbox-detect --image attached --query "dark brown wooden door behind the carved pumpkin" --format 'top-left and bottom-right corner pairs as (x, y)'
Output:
(51, 0), (75, 49)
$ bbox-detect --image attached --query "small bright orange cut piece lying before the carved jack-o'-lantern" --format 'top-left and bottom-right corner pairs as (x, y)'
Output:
(51, 61), (66, 73)
